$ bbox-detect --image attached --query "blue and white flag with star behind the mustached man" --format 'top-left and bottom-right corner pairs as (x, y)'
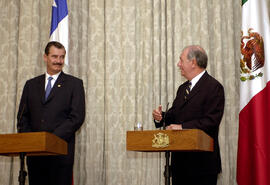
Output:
(50, 0), (68, 65)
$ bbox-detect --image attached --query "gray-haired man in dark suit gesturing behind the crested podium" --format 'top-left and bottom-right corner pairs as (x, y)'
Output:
(153, 46), (225, 185)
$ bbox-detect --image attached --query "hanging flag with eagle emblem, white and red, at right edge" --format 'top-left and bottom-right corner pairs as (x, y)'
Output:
(237, 0), (270, 185)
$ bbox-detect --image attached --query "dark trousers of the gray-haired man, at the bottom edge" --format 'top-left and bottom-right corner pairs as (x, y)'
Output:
(172, 174), (217, 185)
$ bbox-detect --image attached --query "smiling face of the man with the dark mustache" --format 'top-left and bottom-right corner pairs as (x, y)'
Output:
(43, 46), (66, 75)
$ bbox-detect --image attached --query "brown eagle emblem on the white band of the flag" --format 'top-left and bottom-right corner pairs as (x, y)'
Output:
(240, 28), (264, 81)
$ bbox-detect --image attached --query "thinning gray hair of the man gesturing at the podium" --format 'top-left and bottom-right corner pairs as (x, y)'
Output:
(185, 45), (208, 69)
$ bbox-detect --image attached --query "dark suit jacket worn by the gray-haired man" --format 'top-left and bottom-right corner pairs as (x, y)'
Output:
(156, 72), (225, 175)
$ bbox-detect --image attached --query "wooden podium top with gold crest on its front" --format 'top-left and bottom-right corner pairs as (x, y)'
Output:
(126, 129), (214, 152)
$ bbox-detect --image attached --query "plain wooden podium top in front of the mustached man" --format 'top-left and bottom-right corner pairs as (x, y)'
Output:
(0, 132), (67, 156)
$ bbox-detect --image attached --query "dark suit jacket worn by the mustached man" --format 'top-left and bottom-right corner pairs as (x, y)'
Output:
(17, 72), (85, 164)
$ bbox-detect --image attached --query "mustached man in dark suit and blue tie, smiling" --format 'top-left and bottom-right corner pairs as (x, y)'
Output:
(17, 42), (85, 185)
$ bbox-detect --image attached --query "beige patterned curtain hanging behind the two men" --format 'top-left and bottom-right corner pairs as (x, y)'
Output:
(0, 0), (270, 185)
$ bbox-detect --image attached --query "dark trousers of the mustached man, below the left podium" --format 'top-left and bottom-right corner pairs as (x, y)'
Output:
(27, 156), (73, 185)
